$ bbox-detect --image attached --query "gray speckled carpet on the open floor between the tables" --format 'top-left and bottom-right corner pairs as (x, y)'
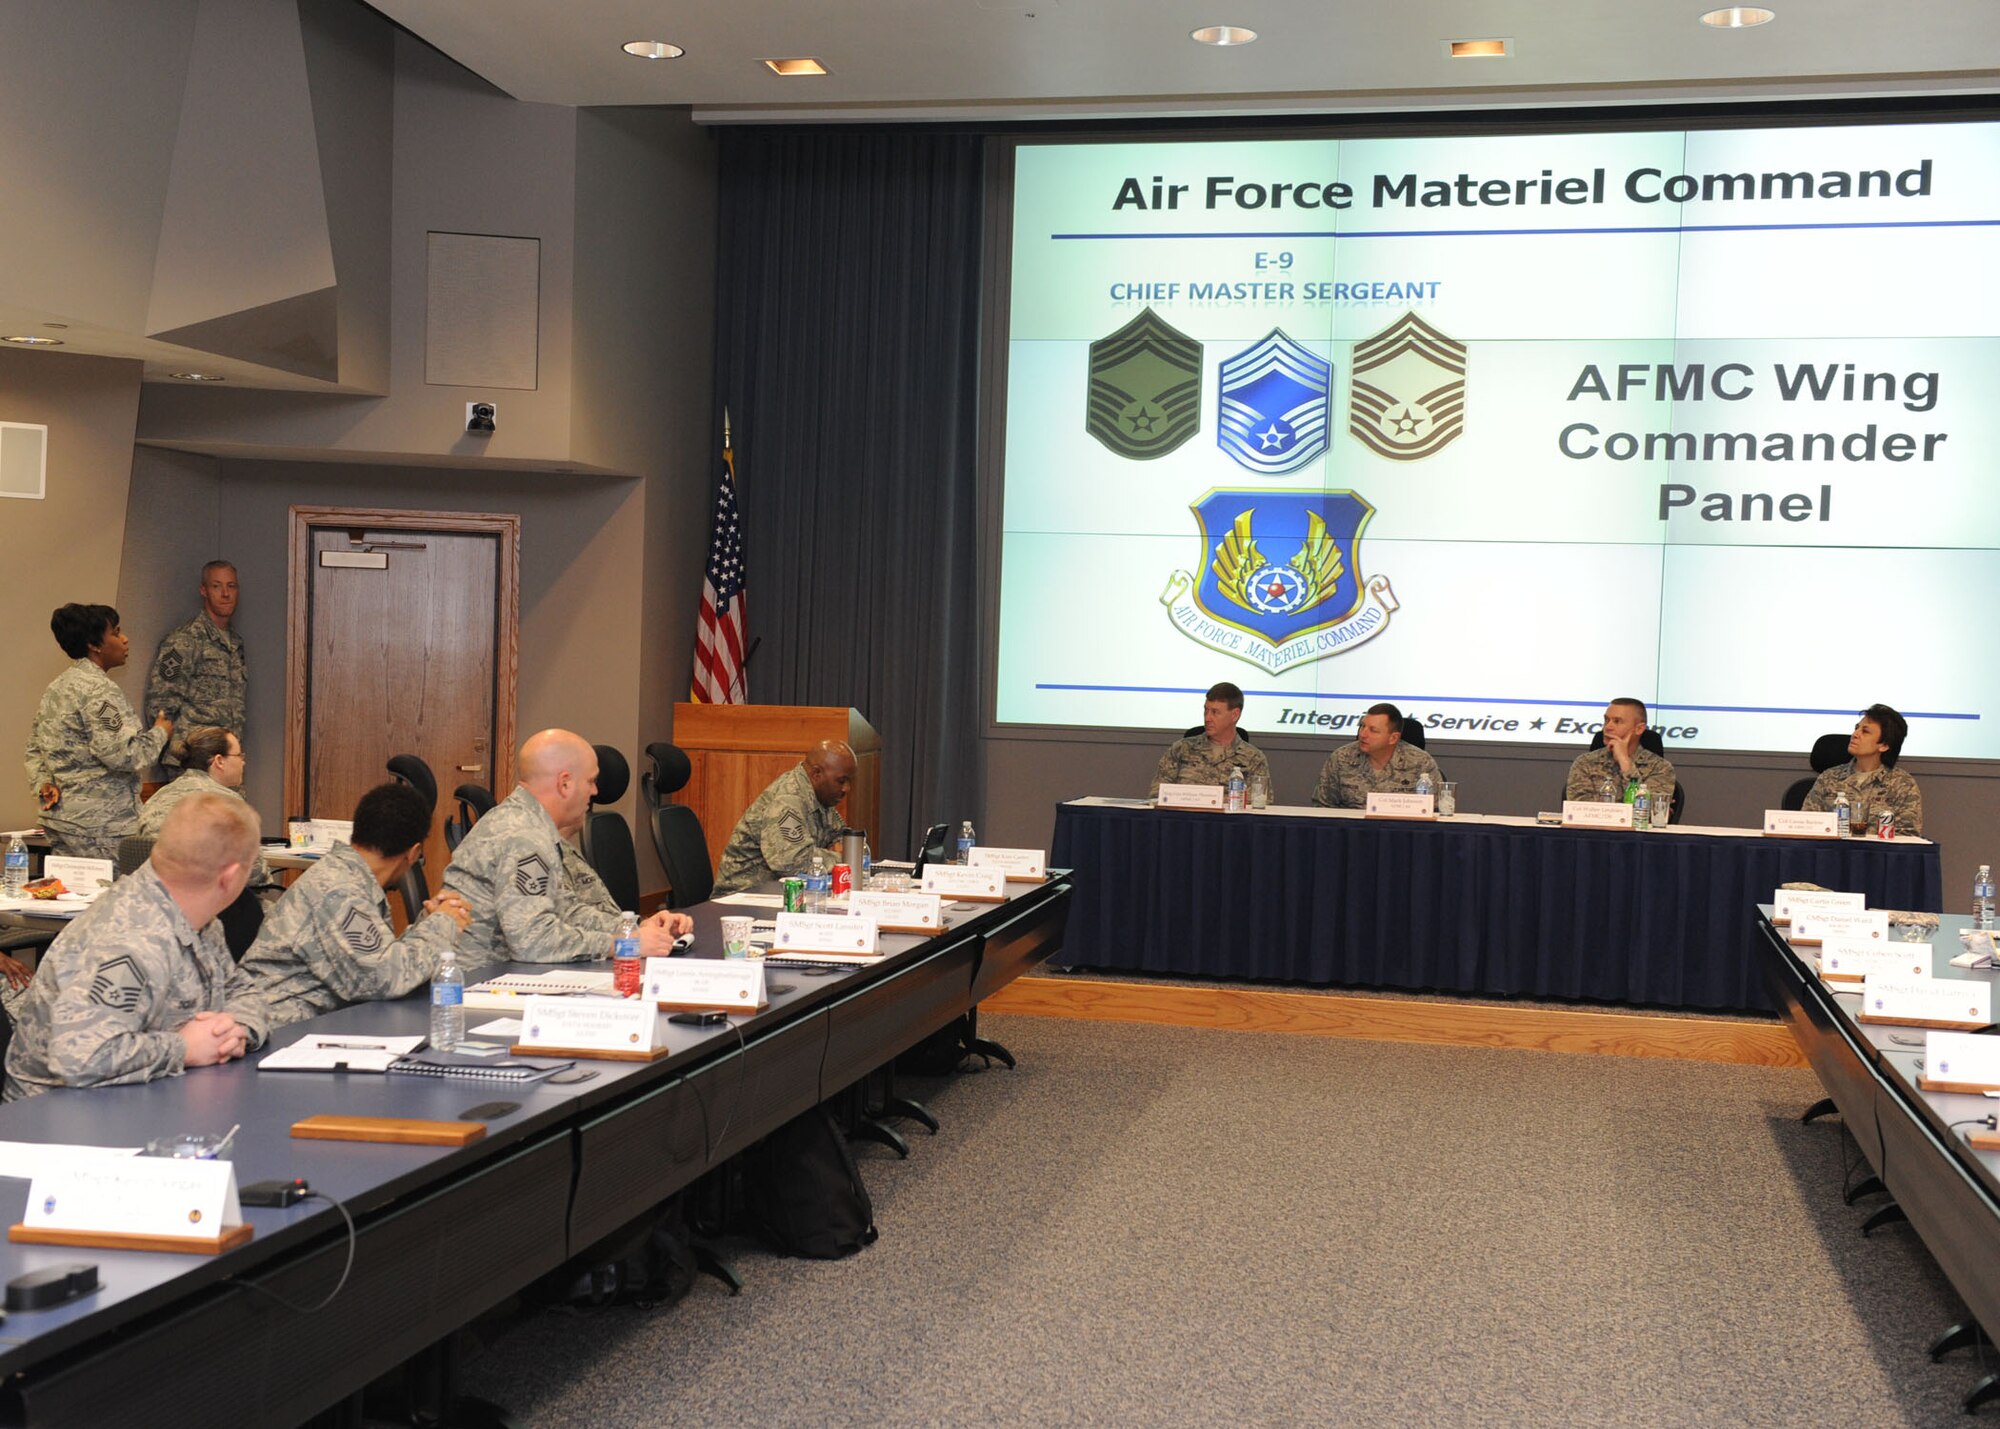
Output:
(468, 1017), (1978, 1427)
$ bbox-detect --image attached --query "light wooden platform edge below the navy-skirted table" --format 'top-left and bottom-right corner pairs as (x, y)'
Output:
(980, 977), (1806, 1067)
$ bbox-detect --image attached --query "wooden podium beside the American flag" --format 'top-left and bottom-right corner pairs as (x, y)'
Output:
(672, 702), (882, 873)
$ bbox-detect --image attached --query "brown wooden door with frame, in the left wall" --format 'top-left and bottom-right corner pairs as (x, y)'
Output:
(284, 506), (520, 896)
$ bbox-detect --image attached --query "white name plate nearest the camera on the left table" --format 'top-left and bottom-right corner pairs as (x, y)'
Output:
(16, 1157), (248, 1249)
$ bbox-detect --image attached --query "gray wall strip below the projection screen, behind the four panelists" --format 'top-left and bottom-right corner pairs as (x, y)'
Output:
(984, 728), (2000, 913)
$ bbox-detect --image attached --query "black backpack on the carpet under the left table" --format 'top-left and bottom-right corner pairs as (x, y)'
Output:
(742, 1107), (876, 1261)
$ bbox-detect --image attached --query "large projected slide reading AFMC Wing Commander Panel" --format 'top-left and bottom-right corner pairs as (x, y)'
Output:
(996, 122), (2000, 759)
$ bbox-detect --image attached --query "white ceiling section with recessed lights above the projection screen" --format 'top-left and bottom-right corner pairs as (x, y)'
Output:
(370, 0), (2000, 122)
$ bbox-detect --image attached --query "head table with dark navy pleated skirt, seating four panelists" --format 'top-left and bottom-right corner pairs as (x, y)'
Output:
(1050, 797), (1942, 1011)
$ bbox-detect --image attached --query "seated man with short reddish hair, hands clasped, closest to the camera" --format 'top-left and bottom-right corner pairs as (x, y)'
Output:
(6, 784), (266, 1101)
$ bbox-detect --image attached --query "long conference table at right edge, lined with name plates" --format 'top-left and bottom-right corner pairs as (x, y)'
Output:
(1750, 907), (2000, 1411)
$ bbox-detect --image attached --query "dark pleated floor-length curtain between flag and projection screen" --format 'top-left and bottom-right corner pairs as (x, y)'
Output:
(716, 128), (984, 857)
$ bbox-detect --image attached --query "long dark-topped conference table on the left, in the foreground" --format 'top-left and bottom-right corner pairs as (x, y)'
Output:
(0, 873), (1072, 1427)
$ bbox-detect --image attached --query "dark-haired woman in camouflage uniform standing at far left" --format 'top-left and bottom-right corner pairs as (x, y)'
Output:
(28, 604), (174, 859)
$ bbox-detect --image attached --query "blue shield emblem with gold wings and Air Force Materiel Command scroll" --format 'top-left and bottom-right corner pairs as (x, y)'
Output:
(1160, 488), (1396, 674)
